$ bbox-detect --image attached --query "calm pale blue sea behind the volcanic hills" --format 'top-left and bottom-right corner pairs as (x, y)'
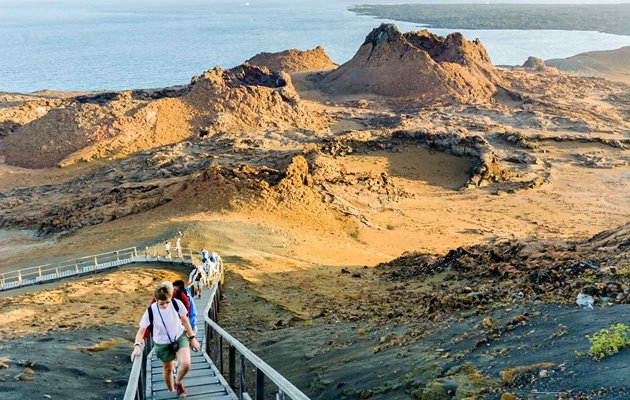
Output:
(0, 0), (630, 92)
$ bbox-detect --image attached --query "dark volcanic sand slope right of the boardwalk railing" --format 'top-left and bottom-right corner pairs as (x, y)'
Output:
(248, 305), (630, 400)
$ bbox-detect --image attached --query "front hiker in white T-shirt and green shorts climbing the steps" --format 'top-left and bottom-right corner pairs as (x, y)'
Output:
(131, 282), (201, 396)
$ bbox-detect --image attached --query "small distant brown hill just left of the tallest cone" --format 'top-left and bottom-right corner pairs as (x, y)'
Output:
(246, 46), (337, 74)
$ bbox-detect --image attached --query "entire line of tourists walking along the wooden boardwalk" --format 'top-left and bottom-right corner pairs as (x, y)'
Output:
(131, 242), (223, 397)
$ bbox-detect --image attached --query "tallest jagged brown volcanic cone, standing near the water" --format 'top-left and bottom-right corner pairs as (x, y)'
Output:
(322, 24), (501, 103)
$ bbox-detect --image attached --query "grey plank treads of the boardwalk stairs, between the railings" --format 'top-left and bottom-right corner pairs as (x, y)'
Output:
(147, 288), (238, 400)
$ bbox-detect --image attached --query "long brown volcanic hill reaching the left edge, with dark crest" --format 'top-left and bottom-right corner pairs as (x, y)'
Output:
(0, 66), (326, 168)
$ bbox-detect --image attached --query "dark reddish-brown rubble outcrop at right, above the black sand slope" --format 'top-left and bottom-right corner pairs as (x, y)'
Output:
(379, 224), (630, 316)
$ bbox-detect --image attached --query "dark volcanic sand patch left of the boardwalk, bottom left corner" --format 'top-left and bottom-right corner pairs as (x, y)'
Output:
(0, 324), (137, 400)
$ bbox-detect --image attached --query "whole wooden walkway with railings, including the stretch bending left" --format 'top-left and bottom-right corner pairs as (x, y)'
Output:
(0, 245), (309, 400)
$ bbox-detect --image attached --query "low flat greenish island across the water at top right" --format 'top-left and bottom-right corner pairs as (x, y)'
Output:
(349, 4), (630, 36)
